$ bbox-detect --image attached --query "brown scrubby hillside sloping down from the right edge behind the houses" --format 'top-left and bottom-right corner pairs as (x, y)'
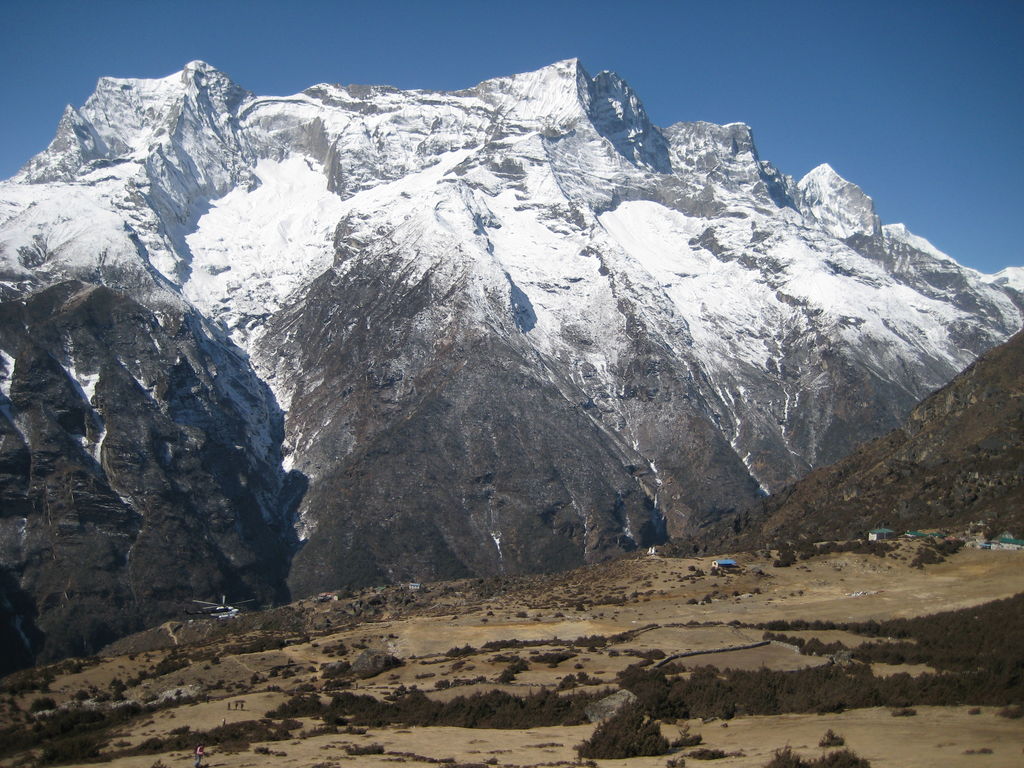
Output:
(752, 333), (1024, 541)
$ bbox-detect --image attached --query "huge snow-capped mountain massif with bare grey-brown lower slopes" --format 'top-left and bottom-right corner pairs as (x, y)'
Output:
(0, 59), (1022, 663)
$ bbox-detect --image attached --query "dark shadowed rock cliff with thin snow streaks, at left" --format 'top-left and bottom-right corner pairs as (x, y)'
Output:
(0, 283), (290, 658)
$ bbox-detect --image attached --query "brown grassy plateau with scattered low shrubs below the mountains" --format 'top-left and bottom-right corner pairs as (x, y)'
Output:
(0, 542), (1024, 768)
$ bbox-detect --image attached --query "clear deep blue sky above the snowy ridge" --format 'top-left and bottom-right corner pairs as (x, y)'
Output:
(0, 0), (1024, 271)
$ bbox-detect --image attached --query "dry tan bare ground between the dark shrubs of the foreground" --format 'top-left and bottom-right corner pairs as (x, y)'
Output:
(0, 544), (1024, 768)
